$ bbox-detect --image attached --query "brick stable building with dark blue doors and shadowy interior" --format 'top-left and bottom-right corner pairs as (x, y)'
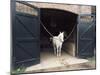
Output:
(11, 1), (96, 69)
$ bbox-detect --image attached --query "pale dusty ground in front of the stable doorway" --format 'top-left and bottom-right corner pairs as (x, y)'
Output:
(14, 52), (96, 73)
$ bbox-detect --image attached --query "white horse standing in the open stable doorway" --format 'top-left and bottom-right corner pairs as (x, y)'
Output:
(52, 32), (64, 56)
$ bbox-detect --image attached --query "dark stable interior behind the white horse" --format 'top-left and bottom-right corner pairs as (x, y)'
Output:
(40, 8), (77, 56)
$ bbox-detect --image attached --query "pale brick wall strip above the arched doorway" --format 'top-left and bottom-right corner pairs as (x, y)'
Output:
(30, 2), (91, 14)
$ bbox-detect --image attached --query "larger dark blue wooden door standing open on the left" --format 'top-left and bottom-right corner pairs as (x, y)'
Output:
(11, 0), (40, 67)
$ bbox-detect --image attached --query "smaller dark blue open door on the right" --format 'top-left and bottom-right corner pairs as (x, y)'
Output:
(77, 14), (96, 58)
